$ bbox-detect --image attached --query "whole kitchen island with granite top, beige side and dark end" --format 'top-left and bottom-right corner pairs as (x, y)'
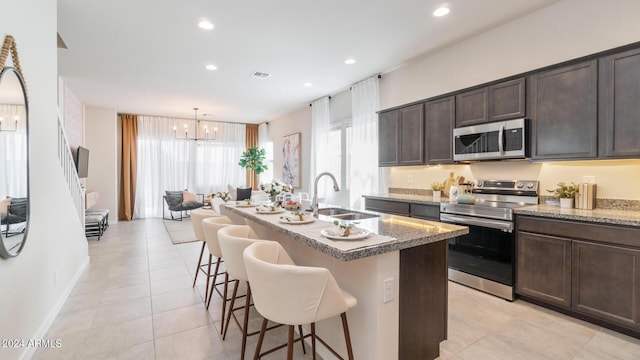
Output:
(221, 205), (468, 360)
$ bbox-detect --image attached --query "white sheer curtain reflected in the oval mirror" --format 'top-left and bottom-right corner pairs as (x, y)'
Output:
(0, 104), (27, 199)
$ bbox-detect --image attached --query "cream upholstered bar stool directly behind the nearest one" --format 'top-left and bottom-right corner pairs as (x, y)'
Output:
(218, 225), (304, 360)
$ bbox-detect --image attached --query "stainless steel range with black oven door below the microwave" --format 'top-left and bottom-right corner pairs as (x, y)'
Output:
(440, 180), (538, 300)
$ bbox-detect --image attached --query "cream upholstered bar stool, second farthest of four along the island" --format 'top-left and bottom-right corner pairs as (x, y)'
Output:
(202, 216), (233, 318)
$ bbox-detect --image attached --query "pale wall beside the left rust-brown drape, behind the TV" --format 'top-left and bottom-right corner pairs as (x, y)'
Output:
(84, 105), (119, 223)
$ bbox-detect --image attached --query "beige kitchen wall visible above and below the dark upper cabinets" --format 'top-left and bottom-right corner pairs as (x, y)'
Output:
(380, 0), (640, 200)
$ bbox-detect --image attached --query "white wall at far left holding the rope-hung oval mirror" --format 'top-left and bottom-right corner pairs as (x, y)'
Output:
(0, 0), (88, 359)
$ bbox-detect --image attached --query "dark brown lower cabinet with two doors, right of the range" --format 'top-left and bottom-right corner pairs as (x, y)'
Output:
(516, 216), (640, 338)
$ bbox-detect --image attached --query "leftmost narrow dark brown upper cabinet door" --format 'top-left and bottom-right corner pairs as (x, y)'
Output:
(378, 110), (400, 166)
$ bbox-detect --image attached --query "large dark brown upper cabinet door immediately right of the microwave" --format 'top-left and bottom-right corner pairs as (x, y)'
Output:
(529, 60), (598, 160)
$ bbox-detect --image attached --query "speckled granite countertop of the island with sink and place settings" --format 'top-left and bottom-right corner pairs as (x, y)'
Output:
(224, 205), (469, 261)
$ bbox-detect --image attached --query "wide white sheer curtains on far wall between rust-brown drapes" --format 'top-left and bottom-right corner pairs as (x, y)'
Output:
(134, 116), (245, 218)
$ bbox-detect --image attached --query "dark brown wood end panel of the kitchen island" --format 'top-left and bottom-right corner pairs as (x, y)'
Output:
(398, 241), (448, 360)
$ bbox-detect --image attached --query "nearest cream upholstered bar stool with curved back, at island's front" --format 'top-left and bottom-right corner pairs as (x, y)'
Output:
(243, 241), (358, 360)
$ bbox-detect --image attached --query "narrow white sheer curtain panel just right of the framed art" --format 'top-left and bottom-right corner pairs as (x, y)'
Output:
(309, 96), (332, 197)
